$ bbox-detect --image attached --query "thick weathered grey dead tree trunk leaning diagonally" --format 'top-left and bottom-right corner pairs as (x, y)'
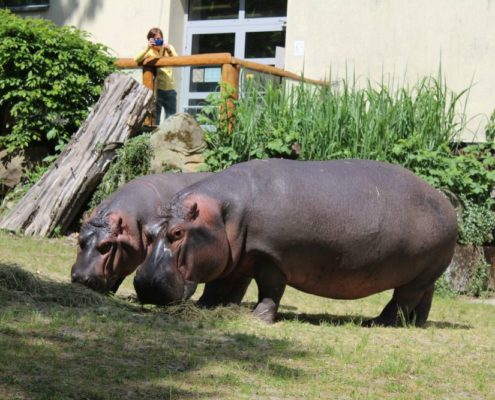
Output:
(0, 73), (153, 236)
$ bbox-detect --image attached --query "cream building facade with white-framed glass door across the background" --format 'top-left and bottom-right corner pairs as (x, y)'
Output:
(4, 0), (495, 140)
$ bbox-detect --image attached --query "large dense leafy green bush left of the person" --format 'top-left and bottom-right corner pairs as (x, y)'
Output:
(0, 10), (115, 151)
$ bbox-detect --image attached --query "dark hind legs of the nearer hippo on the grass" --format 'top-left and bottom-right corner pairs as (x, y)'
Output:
(363, 285), (434, 326)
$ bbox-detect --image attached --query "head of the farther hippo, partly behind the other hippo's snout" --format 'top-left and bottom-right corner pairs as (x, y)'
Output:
(71, 210), (146, 292)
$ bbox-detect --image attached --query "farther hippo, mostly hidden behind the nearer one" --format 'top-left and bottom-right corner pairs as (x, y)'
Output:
(71, 173), (210, 292)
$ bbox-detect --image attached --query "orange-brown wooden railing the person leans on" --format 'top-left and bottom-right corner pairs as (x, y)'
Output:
(116, 53), (326, 124)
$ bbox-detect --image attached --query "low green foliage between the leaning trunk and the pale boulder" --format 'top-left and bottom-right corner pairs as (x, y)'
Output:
(89, 134), (153, 209)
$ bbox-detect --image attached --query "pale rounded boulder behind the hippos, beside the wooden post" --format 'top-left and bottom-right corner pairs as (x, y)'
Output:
(150, 113), (206, 173)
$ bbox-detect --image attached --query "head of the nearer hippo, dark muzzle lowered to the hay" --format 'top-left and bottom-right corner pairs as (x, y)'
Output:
(134, 194), (230, 305)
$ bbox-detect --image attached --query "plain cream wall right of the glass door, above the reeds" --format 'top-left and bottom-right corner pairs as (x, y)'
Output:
(285, 0), (495, 140)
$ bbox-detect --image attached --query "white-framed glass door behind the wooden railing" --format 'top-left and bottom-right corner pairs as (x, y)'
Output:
(181, 0), (287, 115)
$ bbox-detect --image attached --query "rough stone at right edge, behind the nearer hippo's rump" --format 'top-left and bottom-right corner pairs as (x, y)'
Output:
(445, 245), (485, 293)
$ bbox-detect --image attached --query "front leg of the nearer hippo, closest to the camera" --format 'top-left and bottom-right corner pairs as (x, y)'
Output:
(253, 264), (287, 323)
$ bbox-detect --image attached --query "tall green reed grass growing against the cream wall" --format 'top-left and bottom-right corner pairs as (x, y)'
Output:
(203, 70), (468, 167)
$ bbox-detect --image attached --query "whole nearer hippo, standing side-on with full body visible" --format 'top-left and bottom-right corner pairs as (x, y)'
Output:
(135, 159), (457, 326)
